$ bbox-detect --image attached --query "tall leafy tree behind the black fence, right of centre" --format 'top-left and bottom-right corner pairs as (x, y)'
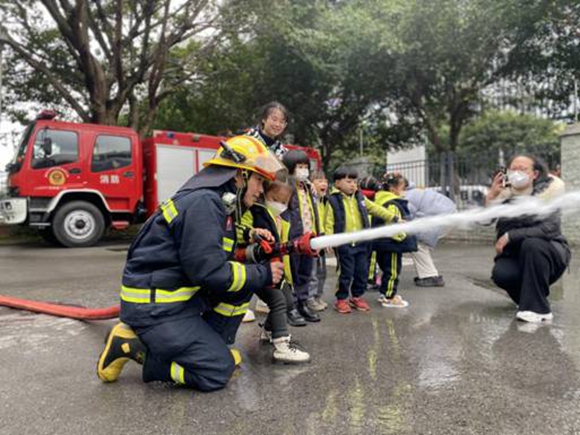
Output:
(360, 0), (548, 151)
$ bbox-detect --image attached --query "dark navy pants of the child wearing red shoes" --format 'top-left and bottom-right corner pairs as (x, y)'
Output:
(336, 243), (369, 299)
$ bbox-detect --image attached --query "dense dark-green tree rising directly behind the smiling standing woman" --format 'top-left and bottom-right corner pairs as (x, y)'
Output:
(156, 0), (404, 167)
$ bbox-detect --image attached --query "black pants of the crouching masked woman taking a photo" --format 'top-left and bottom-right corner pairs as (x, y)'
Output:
(491, 237), (569, 314)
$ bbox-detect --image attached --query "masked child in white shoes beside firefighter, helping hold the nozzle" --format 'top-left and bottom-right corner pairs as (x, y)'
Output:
(238, 181), (310, 363)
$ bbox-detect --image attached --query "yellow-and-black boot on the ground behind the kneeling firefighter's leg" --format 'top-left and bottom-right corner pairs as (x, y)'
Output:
(97, 323), (147, 382)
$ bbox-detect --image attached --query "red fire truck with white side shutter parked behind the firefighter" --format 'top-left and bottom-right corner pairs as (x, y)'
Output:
(0, 111), (321, 247)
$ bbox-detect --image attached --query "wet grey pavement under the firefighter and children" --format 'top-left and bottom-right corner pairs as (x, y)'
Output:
(0, 244), (580, 435)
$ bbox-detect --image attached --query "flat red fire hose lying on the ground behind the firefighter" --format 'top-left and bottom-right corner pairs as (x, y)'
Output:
(0, 296), (119, 320)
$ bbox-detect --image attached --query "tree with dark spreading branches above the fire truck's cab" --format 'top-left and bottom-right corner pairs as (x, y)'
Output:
(0, 0), (245, 131)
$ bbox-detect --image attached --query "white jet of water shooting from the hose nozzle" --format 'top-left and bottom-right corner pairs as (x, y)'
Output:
(310, 192), (580, 250)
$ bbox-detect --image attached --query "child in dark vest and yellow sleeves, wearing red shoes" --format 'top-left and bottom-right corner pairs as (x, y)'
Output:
(324, 167), (397, 314)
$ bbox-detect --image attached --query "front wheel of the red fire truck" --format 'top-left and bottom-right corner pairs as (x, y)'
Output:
(52, 201), (105, 248)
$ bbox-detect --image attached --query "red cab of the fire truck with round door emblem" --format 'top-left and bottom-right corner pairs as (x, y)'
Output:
(0, 112), (143, 247)
